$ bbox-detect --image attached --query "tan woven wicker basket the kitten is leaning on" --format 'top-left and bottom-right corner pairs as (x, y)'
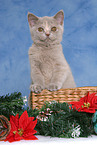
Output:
(30, 86), (97, 109)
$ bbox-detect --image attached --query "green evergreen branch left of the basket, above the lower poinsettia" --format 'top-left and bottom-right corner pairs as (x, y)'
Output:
(0, 92), (24, 119)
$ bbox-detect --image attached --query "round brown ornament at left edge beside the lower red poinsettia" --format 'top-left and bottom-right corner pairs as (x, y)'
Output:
(0, 115), (11, 141)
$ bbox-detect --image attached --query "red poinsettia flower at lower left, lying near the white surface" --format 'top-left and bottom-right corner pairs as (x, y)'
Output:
(5, 111), (37, 142)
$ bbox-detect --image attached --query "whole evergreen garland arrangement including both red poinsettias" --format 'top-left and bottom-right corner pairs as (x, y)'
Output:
(0, 92), (97, 142)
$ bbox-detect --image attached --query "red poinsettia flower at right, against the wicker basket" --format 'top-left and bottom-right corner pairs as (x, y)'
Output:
(70, 93), (97, 113)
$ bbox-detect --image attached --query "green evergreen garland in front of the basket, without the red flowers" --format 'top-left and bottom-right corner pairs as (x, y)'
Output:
(0, 92), (94, 138)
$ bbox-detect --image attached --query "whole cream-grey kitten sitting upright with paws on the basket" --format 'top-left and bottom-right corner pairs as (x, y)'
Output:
(28, 10), (75, 93)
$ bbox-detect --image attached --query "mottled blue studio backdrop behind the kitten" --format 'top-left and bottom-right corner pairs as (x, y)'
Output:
(0, 0), (97, 96)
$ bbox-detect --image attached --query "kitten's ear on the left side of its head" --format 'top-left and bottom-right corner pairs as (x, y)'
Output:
(28, 12), (38, 27)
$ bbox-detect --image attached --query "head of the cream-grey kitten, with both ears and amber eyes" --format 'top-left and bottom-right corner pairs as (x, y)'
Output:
(28, 10), (64, 45)
